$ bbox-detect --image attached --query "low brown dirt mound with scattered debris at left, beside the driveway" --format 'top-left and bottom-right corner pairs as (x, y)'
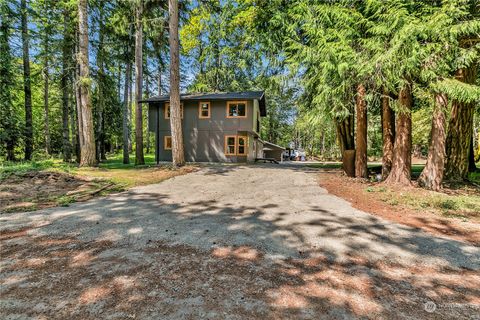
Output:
(0, 171), (114, 213)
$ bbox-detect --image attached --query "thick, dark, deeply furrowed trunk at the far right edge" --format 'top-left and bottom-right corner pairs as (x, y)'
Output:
(445, 66), (477, 181)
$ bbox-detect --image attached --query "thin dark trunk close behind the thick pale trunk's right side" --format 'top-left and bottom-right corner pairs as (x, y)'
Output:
(96, 8), (106, 160)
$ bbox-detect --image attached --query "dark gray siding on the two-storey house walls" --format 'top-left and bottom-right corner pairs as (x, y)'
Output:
(149, 100), (258, 162)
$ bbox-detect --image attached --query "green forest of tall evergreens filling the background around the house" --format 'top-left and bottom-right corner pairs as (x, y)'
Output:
(0, 0), (480, 189)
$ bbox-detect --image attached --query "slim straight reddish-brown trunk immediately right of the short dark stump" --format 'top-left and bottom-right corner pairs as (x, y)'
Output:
(355, 84), (368, 178)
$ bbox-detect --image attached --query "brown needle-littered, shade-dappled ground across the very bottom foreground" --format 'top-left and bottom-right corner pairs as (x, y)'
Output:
(0, 232), (480, 319)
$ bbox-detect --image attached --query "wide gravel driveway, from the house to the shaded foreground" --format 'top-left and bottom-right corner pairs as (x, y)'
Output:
(0, 165), (480, 319)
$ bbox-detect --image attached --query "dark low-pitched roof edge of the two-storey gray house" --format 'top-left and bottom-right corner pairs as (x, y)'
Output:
(141, 91), (267, 117)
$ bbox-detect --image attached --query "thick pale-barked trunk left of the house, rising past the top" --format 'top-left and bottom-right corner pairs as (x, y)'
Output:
(78, 0), (97, 167)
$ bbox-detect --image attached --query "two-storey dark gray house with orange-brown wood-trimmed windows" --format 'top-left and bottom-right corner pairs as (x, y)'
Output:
(143, 91), (284, 162)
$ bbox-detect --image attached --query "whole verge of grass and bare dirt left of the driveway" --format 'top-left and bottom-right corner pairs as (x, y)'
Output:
(0, 154), (193, 212)
